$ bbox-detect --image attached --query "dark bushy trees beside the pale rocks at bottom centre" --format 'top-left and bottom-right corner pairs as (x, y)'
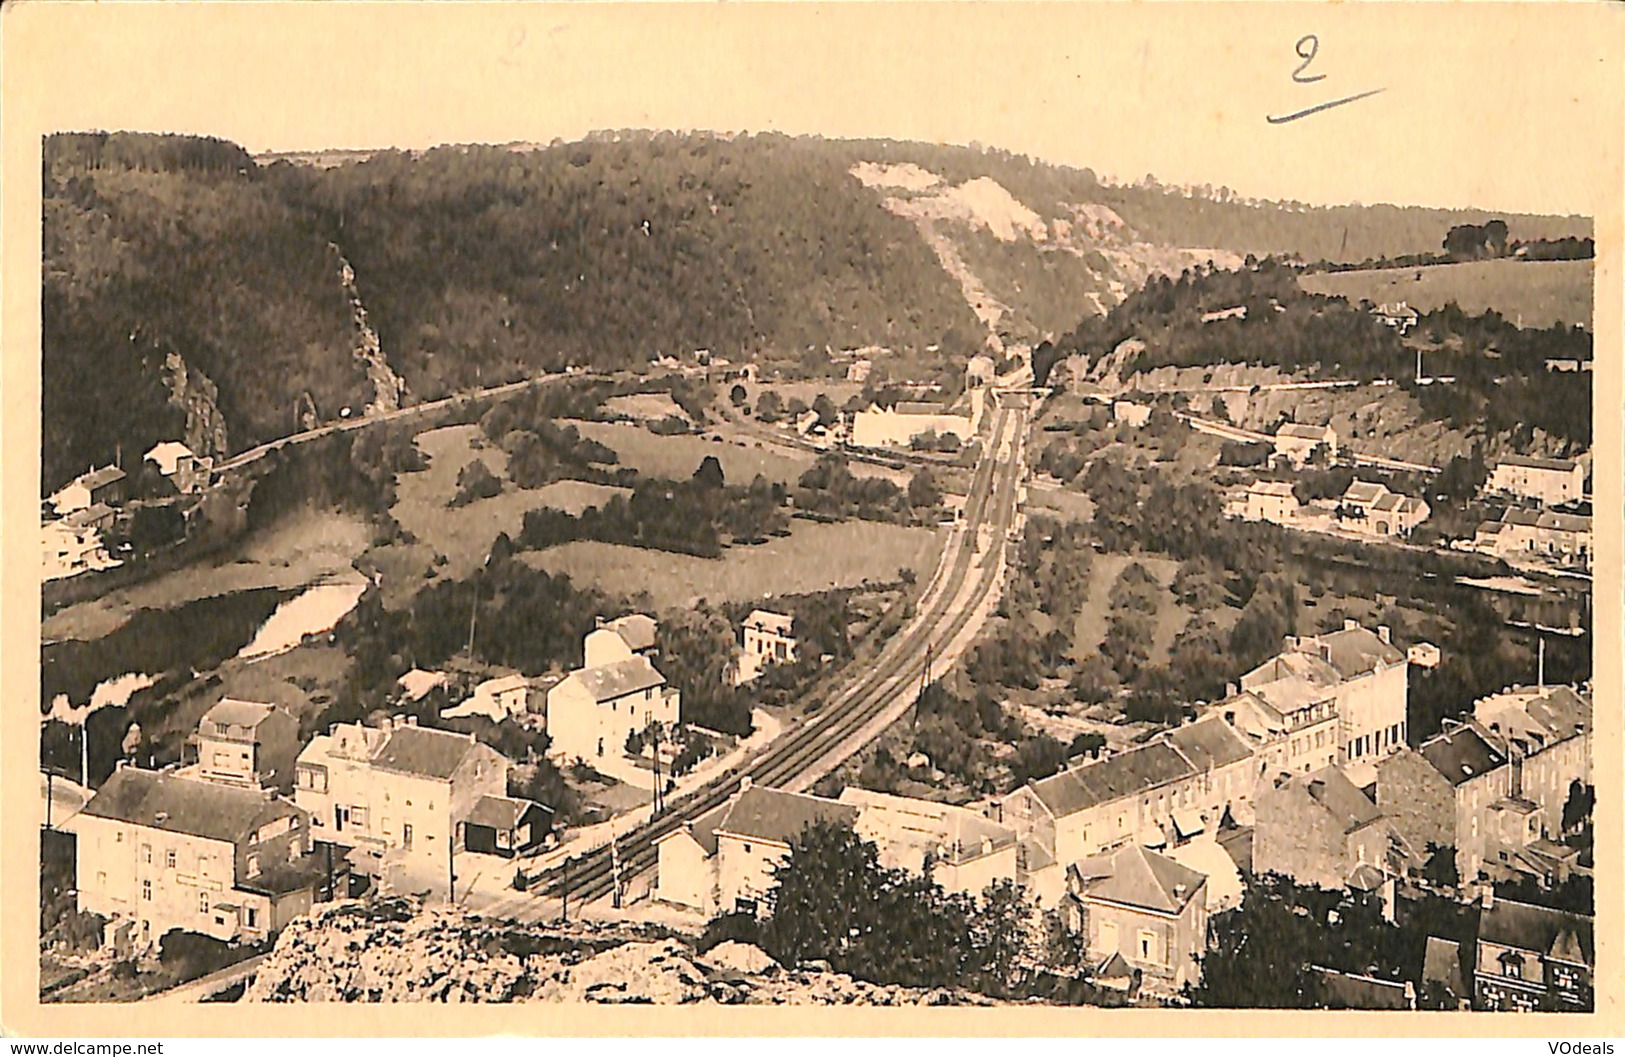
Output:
(736, 823), (1040, 997)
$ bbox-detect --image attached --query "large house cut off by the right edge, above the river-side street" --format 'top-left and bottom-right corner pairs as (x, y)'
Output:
(1472, 686), (1593, 837)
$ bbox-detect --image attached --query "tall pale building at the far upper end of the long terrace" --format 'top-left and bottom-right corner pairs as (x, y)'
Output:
(1242, 620), (1411, 774)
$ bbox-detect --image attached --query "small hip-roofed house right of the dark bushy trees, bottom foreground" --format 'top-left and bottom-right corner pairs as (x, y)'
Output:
(1061, 844), (1207, 995)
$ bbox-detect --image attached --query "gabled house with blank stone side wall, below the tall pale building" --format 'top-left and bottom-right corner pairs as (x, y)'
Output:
(1253, 768), (1409, 906)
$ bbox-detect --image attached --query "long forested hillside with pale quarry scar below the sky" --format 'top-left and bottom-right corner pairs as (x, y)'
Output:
(42, 132), (1589, 491)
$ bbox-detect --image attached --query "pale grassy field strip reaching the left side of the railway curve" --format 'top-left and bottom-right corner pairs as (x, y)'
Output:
(523, 522), (938, 610)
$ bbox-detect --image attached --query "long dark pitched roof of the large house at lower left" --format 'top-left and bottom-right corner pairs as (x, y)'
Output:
(83, 766), (301, 844)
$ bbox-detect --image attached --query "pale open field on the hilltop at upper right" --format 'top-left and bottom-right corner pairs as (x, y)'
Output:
(1298, 259), (1594, 327)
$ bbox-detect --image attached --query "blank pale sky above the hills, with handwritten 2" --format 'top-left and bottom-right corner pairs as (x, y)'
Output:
(5, 2), (1625, 215)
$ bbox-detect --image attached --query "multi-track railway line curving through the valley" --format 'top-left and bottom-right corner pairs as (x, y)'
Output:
(528, 401), (1024, 904)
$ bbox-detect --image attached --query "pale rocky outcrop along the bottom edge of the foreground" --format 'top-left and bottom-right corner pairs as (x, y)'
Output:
(244, 904), (991, 1005)
